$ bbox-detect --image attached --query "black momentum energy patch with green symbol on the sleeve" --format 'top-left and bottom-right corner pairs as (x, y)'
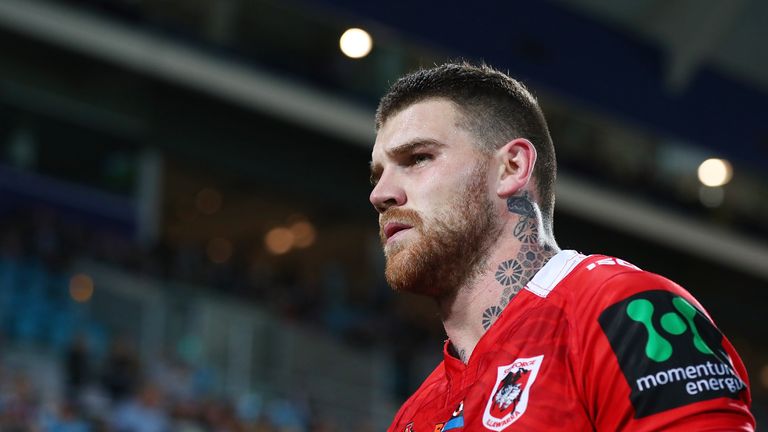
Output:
(599, 290), (744, 418)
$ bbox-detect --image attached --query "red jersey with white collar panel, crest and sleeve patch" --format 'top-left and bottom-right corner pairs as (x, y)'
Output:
(389, 251), (755, 432)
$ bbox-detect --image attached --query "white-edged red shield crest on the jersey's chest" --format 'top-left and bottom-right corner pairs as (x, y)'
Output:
(483, 355), (544, 431)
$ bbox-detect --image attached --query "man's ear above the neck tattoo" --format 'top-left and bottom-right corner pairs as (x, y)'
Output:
(496, 138), (536, 198)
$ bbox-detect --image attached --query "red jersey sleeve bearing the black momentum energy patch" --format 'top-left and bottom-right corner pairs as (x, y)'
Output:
(572, 269), (755, 431)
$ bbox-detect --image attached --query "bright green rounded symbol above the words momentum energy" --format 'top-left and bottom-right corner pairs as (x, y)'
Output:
(626, 296), (714, 363)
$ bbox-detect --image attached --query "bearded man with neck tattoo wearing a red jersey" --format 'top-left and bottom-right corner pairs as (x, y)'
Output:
(370, 64), (754, 432)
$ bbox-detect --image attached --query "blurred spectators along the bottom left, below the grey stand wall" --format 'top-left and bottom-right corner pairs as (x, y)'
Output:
(0, 339), (352, 432)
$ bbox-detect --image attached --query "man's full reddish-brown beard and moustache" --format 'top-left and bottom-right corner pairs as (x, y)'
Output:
(379, 163), (501, 298)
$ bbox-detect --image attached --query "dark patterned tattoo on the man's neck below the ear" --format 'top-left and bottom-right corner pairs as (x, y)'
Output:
(482, 192), (552, 330)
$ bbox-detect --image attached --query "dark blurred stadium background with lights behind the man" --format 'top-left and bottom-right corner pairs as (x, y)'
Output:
(0, 0), (768, 432)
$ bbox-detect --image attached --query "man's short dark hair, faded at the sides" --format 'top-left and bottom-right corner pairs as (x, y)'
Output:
(376, 62), (557, 227)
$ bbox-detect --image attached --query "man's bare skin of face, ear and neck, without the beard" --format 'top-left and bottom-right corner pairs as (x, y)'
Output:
(370, 98), (558, 363)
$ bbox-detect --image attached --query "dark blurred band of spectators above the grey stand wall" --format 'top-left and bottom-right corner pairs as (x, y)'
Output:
(0, 208), (408, 346)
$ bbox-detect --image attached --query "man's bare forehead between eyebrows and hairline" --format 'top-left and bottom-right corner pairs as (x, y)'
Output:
(372, 99), (470, 160)
